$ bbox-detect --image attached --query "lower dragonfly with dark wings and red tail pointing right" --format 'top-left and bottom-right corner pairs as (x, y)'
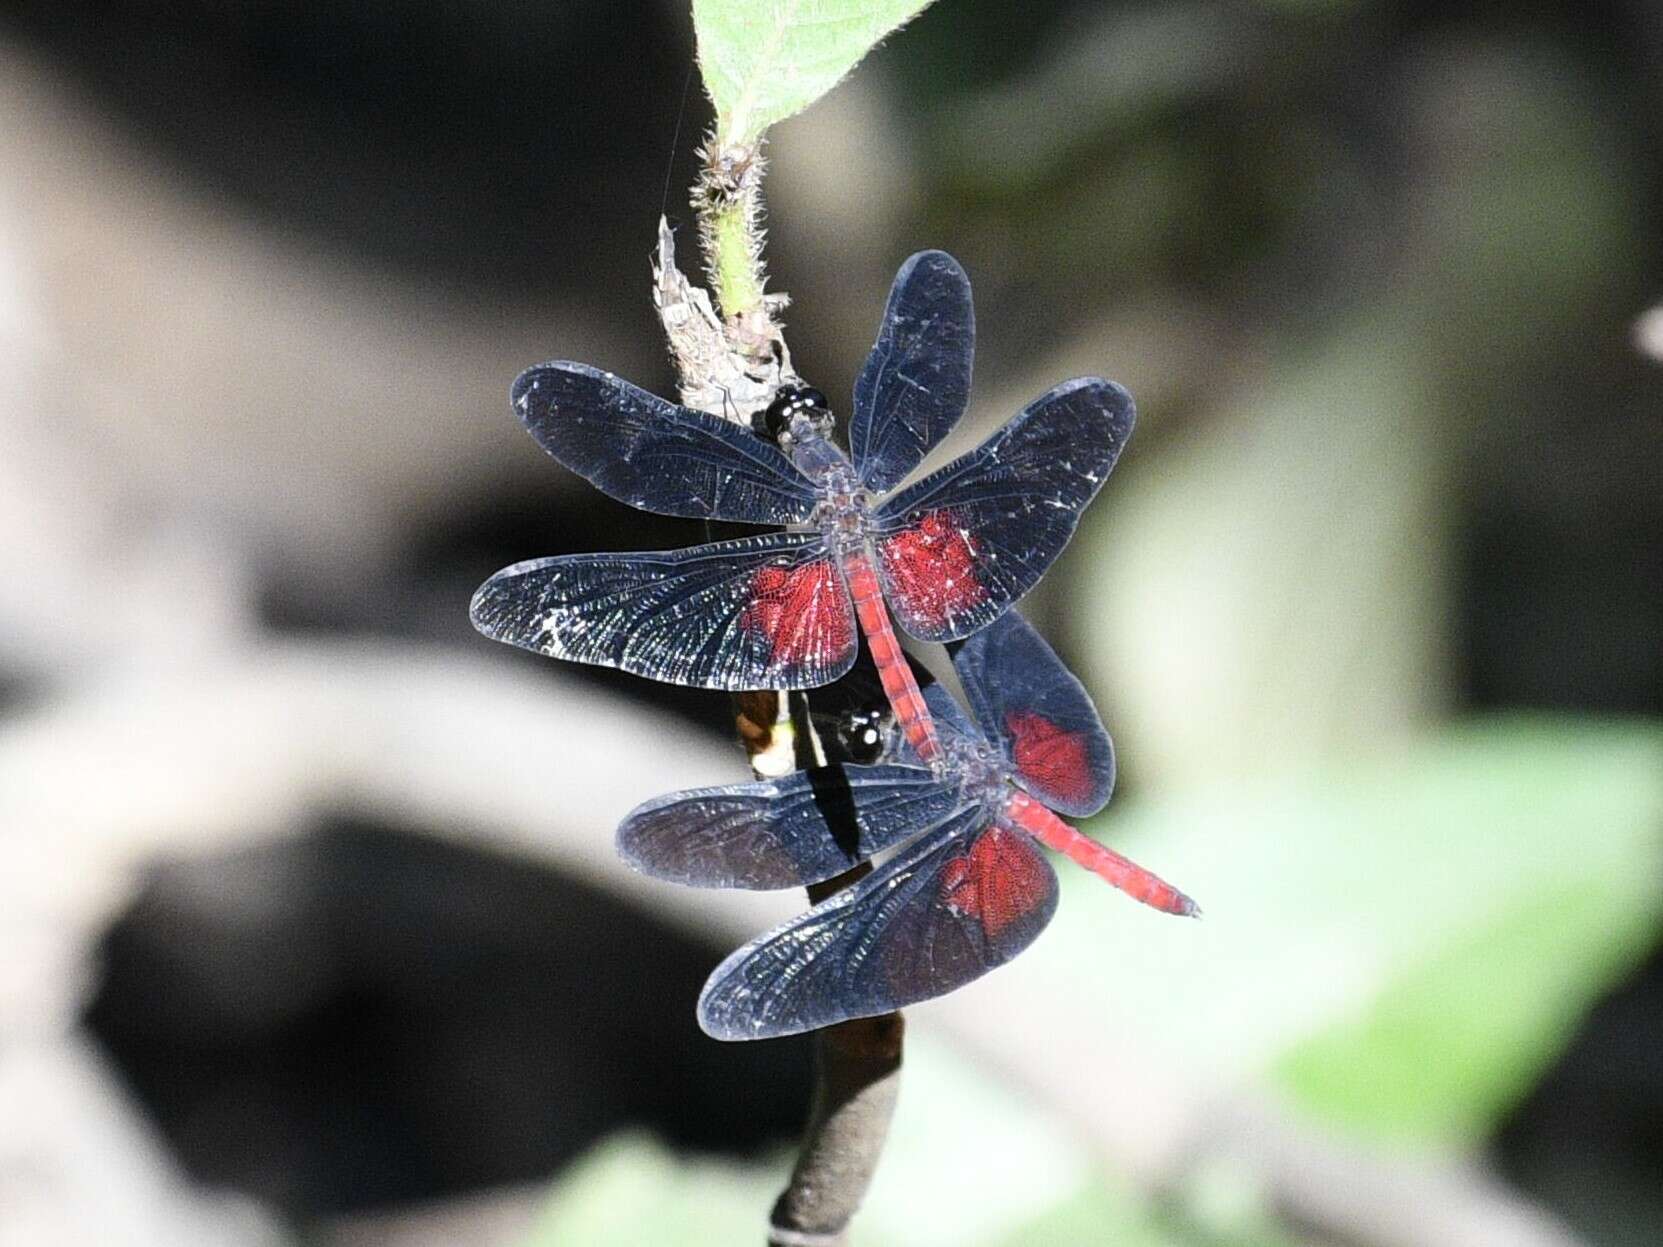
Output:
(619, 612), (1201, 1039)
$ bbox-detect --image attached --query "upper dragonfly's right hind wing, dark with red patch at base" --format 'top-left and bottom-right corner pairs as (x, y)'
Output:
(876, 377), (1134, 640)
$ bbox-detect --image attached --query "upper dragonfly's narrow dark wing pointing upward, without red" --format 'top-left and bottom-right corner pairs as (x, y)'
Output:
(848, 251), (976, 494)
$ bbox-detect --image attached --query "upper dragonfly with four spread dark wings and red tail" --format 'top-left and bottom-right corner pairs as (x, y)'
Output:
(471, 251), (1136, 762)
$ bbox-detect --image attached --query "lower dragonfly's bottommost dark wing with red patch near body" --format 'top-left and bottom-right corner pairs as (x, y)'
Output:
(698, 806), (1056, 1039)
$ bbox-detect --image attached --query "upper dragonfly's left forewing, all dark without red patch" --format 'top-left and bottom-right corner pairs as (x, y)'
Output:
(511, 361), (817, 525)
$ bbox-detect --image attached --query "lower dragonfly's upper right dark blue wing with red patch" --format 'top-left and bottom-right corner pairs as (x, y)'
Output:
(953, 610), (1114, 818)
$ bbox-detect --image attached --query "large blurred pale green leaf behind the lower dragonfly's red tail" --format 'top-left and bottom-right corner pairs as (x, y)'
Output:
(1014, 718), (1663, 1149)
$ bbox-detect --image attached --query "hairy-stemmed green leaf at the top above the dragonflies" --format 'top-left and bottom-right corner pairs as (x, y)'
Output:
(693, 0), (930, 143)
